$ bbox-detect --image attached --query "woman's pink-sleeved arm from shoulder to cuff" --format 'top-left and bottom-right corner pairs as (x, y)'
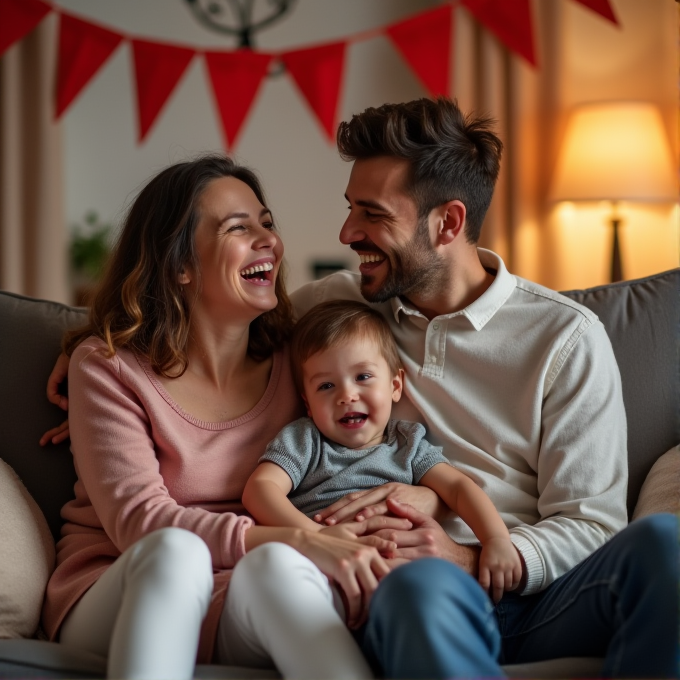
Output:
(64, 340), (253, 569)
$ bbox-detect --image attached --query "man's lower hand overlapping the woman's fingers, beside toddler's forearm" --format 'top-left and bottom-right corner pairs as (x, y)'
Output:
(375, 499), (480, 578)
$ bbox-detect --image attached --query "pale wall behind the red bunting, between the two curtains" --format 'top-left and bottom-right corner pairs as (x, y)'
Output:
(57, 0), (438, 290)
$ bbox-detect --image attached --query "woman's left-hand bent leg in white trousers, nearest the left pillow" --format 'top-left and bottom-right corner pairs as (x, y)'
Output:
(60, 528), (213, 680)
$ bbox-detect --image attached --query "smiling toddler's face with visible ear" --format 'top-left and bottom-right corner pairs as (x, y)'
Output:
(302, 337), (404, 449)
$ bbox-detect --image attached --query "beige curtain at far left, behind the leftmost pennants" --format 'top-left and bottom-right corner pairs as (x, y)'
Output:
(0, 14), (70, 302)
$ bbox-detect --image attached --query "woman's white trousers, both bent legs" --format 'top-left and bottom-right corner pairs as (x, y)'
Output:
(60, 528), (372, 680)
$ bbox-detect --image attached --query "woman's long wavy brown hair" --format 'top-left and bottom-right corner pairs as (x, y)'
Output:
(63, 155), (293, 378)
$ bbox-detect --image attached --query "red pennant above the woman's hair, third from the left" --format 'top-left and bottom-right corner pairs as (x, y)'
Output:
(132, 40), (196, 142)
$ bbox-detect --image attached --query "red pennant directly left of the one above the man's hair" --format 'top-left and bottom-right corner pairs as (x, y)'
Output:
(281, 42), (346, 141)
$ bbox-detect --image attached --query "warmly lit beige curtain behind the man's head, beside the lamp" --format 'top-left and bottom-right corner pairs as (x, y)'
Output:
(453, 2), (563, 285)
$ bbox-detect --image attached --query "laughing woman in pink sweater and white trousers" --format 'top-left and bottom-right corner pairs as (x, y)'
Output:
(43, 156), (408, 678)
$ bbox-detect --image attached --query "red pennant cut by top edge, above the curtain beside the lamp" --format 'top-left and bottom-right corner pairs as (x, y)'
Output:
(462, 0), (537, 66)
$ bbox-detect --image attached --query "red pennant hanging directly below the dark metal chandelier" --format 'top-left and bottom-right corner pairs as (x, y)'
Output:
(205, 49), (273, 148)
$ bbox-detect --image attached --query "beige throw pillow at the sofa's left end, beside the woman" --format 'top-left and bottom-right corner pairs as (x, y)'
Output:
(0, 460), (55, 638)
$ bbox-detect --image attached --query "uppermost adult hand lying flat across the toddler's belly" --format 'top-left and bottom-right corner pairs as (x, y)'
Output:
(314, 482), (449, 526)
